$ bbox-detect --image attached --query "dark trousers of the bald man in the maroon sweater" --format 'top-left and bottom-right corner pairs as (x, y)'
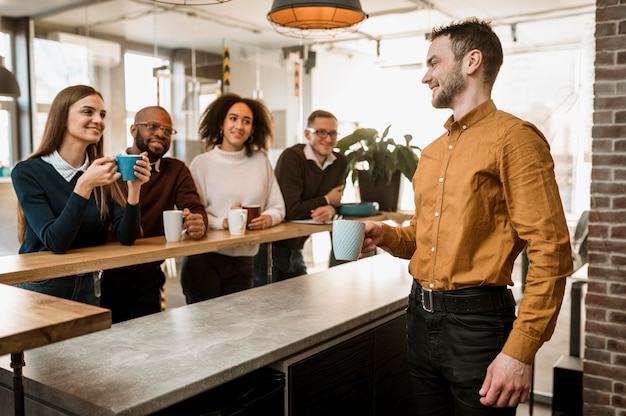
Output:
(100, 266), (165, 323)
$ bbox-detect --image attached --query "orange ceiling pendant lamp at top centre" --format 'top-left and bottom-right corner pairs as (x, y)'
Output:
(267, 0), (367, 37)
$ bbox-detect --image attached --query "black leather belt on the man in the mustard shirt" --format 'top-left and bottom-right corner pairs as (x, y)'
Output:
(411, 280), (515, 313)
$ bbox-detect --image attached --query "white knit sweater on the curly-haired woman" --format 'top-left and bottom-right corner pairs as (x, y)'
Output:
(189, 147), (285, 256)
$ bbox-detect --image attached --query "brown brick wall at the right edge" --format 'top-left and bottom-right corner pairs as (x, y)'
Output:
(583, 0), (626, 416)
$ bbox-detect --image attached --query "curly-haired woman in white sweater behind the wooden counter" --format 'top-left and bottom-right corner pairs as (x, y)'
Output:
(181, 94), (285, 303)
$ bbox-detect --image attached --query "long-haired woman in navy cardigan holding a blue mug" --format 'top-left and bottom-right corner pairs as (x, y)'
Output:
(11, 85), (150, 305)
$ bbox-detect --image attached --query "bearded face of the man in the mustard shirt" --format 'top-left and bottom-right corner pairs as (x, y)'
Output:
(422, 36), (466, 108)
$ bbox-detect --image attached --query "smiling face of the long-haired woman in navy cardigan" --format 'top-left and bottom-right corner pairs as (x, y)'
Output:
(64, 94), (106, 147)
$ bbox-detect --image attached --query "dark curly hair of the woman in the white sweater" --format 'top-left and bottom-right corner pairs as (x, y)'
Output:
(198, 93), (274, 156)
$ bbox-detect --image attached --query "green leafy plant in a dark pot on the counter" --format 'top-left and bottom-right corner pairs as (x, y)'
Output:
(336, 126), (422, 211)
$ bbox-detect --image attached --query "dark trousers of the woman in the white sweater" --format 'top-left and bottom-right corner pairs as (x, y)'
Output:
(180, 253), (254, 304)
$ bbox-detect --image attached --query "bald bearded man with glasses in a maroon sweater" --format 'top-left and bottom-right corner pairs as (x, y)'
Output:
(100, 106), (208, 323)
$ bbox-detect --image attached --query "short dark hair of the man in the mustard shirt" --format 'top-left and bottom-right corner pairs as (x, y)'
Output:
(429, 17), (504, 89)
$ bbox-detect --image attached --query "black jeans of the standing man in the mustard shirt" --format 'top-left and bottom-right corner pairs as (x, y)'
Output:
(407, 286), (516, 416)
